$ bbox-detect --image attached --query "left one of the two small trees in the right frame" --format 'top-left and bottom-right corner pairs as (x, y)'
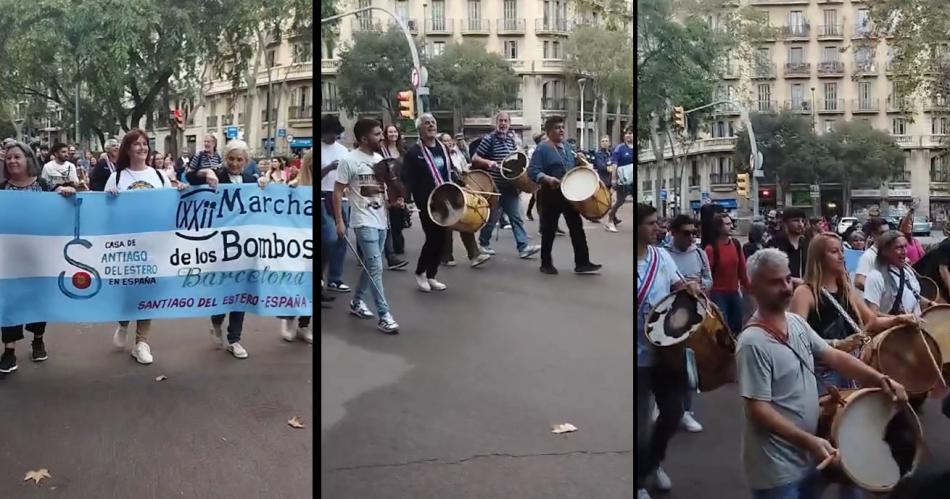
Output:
(734, 112), (832, 204)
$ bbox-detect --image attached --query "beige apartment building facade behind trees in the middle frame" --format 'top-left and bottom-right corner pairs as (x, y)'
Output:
(320, 0), (632, 144)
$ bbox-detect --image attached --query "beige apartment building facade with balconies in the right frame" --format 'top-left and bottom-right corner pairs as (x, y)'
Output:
(638, 0), (950, 223)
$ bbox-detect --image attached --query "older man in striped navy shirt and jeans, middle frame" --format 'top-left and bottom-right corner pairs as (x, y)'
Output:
(472, 112), (541, 258)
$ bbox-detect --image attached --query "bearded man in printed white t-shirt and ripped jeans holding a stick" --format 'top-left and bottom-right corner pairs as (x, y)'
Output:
(333, 119), (399, 334)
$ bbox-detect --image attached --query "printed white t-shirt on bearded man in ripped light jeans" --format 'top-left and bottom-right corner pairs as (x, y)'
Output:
(336, 146), (389, 229)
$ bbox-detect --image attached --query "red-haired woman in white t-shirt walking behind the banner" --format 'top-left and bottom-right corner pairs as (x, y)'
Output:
(105, 128), (188, 364)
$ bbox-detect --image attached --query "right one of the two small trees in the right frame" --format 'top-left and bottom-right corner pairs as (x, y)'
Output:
(820, 121), (905, 213)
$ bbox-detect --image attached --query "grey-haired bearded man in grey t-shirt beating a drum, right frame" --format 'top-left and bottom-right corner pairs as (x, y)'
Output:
(736, 248), (907, 499)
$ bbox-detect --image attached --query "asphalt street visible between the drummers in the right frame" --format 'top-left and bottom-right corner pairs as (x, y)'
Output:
(657, 385), (950, 499)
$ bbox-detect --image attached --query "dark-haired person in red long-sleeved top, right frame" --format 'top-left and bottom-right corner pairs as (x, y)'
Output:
(705, 213), (749, 334)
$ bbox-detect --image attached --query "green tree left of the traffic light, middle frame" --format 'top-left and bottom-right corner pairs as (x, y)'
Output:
(337, 29), (420, 123)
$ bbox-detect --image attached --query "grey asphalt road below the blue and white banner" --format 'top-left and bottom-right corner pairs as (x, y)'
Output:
(0, 315), (316, 499)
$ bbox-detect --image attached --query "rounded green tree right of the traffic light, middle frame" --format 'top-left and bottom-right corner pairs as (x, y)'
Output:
(428, 40), (521, 131)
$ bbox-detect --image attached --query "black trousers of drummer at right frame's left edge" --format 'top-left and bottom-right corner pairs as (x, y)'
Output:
(636, 365), (686, 489)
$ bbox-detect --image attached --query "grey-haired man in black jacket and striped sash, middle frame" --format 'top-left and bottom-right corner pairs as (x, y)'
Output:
(401, 113), (461, 293)
